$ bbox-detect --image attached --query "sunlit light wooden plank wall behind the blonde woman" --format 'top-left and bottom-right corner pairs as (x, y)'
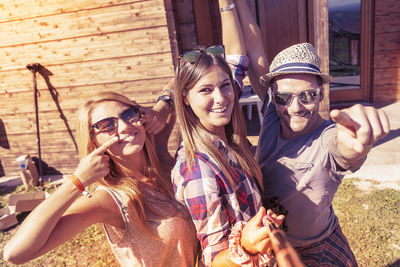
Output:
(0, 0), (176, 176)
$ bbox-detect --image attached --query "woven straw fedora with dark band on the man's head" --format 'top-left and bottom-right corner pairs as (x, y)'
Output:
(260, 43), (333, 87)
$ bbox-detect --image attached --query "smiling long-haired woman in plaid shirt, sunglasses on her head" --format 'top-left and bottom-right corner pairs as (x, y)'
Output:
(171, 16), (283, 266)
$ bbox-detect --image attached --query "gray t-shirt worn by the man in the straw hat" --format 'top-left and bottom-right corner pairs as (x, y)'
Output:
(256, 96), (347, 247)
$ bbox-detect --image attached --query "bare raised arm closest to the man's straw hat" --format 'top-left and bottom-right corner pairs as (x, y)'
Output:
(236, 0), (269, 100)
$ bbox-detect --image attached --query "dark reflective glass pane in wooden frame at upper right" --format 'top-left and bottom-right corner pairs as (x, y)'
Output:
(328, 0), (361, 90)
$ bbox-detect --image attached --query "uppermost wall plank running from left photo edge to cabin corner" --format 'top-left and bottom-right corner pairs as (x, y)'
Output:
(0, 1), (167, 47)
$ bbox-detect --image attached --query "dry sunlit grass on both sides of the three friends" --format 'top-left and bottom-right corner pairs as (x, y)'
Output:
(0, 179), (400, 267)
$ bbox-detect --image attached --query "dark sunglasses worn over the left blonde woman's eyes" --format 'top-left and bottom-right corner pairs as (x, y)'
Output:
(90, 106), (142, 133)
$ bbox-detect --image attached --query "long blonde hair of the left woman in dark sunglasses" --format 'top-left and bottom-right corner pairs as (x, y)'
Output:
(77, 92), (173, 230)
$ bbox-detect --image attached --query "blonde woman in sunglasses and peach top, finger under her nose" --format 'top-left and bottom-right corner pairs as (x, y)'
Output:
(4, 93), (197, 266)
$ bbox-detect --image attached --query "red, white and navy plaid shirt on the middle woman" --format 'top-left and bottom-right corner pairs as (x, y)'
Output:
(171, 140), (261, 266)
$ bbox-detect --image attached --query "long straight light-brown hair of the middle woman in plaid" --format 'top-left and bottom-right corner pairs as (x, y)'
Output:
(175, 49), (263, 189)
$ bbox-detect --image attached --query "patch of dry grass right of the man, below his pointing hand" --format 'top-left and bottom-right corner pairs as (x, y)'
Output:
(333, 179), (400, 267)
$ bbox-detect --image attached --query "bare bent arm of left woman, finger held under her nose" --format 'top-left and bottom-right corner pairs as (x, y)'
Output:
(3, 139), (123, 264)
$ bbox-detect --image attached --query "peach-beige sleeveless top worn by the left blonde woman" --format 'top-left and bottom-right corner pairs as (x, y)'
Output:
(98, 187), (199, 267)
